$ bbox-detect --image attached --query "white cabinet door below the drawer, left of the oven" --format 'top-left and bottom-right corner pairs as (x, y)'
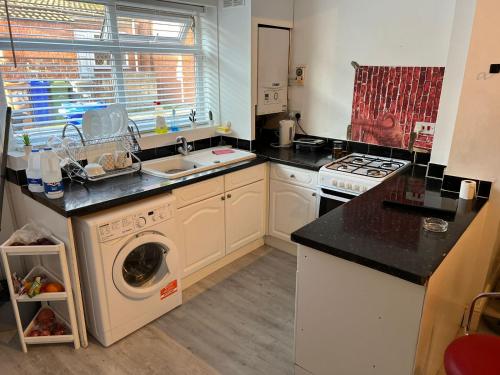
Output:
(269, 180), (317, 241)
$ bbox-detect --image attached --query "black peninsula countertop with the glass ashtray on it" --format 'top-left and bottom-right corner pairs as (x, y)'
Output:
(292, 166), (487, 285)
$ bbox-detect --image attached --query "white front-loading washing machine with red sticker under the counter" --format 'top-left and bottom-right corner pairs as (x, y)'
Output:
(74, 194), (182, 346)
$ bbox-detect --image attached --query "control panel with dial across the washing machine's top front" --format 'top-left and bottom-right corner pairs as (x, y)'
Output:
(97, 205), (173, 242)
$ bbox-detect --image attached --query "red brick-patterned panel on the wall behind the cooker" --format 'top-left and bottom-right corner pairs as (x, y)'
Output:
(351, 66), (444, 150)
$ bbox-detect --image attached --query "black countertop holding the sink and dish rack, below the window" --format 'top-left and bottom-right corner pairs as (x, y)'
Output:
(21, 157), (267, 217)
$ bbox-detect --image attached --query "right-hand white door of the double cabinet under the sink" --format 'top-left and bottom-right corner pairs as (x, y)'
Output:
(226, 180), (266, 254)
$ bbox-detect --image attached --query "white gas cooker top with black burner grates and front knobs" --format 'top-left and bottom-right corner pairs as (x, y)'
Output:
(319, 153), (410, 195)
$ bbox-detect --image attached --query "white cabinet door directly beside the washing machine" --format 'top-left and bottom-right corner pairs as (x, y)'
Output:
(178, 195), (225, 276)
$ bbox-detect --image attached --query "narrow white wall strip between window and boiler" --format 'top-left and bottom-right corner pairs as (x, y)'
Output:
(219, 0), (253, 139)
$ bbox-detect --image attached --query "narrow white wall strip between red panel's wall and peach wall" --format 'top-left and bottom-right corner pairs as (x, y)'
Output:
(431, 0), (476, 165)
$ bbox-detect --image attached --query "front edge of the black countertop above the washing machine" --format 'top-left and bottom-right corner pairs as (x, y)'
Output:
(21, 155), (268, 217)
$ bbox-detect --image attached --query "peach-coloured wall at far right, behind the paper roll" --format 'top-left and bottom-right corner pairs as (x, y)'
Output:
(446, 0), (500, 280)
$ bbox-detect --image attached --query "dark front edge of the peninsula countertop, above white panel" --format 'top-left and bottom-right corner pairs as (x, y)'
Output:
(291, 233), (430, 285)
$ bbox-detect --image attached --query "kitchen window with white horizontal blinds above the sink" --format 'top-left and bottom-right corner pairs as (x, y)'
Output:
(0, 0), (219, 145)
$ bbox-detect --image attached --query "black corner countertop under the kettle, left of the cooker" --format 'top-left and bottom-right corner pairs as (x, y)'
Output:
(256, 145), (333, 171)
